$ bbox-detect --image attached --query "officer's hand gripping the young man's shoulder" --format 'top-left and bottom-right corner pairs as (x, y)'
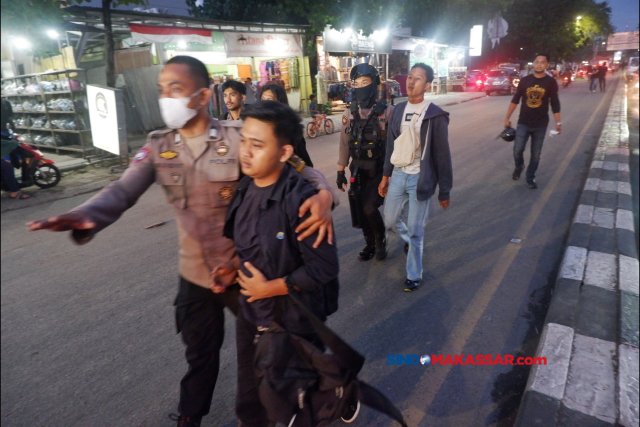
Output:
(296, 190), (333, 248)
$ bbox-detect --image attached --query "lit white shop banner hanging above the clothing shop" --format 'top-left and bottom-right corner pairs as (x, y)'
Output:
(223, 32), (302, 58)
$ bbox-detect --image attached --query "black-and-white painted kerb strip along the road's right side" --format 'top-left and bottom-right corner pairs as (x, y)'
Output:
(515, 80), (639, 427)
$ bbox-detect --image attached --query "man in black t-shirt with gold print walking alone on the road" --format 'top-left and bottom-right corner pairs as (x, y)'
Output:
(504, 53), (562, 189)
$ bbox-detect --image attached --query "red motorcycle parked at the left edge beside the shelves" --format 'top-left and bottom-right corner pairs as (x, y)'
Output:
(2, 132), (62, 190)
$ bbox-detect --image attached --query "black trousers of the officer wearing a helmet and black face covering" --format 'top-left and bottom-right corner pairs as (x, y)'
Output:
(350, 162), (385, 244)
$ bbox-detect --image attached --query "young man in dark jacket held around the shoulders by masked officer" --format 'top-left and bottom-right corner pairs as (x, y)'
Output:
(224, 101), (350, 427)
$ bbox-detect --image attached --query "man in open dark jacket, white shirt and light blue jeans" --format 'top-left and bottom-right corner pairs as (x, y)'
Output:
(378, 63), (453, 292)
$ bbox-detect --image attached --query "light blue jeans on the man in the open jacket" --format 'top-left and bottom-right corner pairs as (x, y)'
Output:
(384, 168), (429, 281)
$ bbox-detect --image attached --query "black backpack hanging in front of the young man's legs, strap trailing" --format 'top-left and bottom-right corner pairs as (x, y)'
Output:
(254, 294), (407, 427)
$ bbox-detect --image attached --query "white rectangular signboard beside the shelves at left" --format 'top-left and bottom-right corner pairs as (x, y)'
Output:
(87, 85), (128, 156)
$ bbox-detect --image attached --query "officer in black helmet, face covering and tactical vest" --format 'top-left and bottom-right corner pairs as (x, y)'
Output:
(337, 64), (392, 261)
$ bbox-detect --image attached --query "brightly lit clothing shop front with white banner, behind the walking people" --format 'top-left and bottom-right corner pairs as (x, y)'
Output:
(130, 24), (311, 116)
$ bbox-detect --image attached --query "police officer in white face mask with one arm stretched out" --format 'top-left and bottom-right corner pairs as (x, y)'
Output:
(27, 56), (337, 427)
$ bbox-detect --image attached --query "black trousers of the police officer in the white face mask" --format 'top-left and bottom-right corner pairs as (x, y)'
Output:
(174, 277), (240, 418)
